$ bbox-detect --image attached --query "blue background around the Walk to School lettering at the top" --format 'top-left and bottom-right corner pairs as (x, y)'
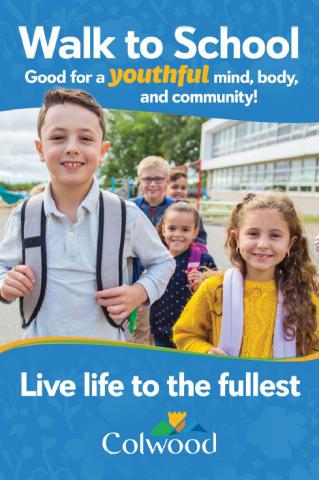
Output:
(0, 0), (319, 122)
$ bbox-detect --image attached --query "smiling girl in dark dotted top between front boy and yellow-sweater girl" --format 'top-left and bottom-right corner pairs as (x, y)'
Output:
(150, 202), (216, 348)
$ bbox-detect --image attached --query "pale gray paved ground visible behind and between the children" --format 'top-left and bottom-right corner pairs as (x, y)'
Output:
(0, 208), (319, 345)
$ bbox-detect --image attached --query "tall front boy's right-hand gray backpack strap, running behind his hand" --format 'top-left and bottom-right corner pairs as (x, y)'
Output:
(96, 190), (132, 341)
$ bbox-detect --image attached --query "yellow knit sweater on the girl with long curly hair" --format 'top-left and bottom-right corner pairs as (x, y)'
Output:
(173, 275), (319, 358)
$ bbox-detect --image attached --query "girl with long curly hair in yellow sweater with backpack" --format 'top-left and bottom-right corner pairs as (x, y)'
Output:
(174, 193), (319, 358)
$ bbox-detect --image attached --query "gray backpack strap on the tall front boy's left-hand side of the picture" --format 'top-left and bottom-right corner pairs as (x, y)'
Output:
(20, 194), (47, 328)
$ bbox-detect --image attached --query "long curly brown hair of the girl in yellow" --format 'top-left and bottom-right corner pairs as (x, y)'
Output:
(225, 193), (319, 355)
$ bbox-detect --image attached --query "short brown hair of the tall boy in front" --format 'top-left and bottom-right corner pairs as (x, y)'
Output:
(38, 88), (106, 139)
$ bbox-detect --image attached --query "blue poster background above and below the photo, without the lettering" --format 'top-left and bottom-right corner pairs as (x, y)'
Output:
(0, 0), (319, 480)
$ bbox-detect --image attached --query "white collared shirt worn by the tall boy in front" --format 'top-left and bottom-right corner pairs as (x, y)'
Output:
(0, 179), (175, 340)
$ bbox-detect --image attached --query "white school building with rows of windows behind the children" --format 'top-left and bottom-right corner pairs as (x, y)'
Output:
(201, 119), (319, 211)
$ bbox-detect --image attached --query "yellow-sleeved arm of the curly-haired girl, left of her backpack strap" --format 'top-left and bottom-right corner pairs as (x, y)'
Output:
(173, 278), (221, 353)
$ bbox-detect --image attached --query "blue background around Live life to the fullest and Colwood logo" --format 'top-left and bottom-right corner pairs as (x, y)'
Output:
(0, 345), (319, 480)
